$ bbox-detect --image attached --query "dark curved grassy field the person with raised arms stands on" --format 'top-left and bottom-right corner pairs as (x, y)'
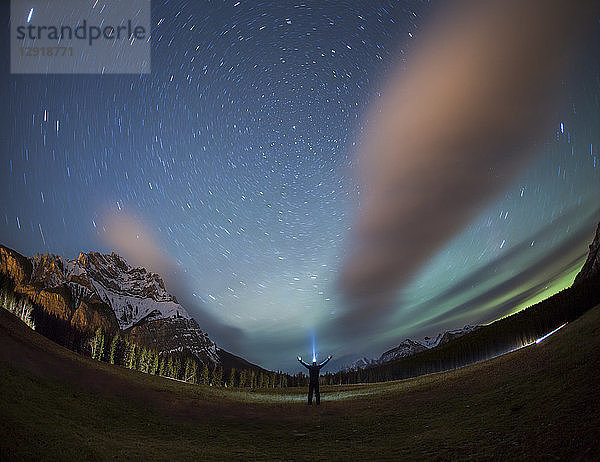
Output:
(0, 307), (600, 461)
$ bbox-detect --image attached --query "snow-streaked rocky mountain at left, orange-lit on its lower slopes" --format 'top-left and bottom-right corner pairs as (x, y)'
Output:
(0, 245), (257, 368)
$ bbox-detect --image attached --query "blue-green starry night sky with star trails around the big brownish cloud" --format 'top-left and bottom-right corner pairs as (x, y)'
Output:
(0, 0), (600, 370)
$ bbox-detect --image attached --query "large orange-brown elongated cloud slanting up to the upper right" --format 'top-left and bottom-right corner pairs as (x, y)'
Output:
(341, 0), (597, 327)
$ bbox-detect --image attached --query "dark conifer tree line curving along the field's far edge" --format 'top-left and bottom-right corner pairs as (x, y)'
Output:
(0, 268), (600, 388)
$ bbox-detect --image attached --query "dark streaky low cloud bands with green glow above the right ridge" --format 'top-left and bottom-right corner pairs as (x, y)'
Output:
(328, 205), (600, 359)
